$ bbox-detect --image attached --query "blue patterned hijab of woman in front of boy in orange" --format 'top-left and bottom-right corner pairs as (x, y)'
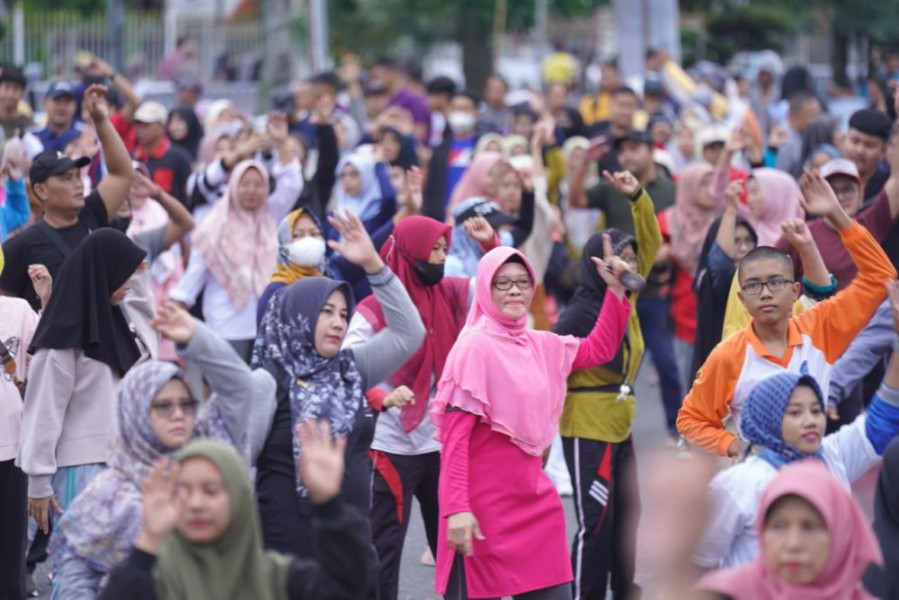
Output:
(740, 372), (824, 469)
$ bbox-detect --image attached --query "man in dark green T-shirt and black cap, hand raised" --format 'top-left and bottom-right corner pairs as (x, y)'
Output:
(568, 130), (675, 235)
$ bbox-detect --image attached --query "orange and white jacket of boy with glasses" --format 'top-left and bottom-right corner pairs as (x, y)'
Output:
(677, 221), (896, 456)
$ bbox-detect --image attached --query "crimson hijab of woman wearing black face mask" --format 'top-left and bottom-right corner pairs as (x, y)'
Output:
(359, 216), (464, 433)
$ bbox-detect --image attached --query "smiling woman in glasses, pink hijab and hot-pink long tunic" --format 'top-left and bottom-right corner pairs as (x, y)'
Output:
(431, 241), (630, 600)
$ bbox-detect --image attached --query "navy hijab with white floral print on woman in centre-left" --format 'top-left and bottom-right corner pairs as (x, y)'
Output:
(252, 277), (365, 497)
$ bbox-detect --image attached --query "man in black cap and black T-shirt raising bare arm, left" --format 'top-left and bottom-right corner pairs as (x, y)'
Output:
(0, 85), (134, 310)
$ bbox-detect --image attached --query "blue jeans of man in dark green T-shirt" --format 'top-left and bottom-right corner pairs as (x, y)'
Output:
(637, 298), (684, 433)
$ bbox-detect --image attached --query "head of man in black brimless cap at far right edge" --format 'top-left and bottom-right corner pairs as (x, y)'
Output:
(843, 108), (893, 200)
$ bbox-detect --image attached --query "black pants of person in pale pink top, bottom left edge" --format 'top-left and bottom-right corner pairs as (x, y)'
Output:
(0, 460), (28, 600)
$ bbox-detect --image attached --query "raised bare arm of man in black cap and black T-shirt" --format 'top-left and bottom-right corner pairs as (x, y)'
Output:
(84, 84), (134, 221)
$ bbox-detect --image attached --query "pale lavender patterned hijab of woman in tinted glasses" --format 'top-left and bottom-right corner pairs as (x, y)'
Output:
(50, 360), (232, 573)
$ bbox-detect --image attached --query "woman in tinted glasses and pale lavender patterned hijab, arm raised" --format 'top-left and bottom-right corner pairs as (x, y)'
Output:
(50, 303), (275, 600)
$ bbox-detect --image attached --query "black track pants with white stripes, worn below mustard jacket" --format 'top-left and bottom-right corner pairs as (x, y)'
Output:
(562, 437), (640, 600)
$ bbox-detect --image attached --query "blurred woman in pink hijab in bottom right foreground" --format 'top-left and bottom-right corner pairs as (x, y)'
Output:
(699, 459), (883, 600)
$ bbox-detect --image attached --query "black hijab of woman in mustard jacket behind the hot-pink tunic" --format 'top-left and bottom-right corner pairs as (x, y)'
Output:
(553, 229), (637, 371)
